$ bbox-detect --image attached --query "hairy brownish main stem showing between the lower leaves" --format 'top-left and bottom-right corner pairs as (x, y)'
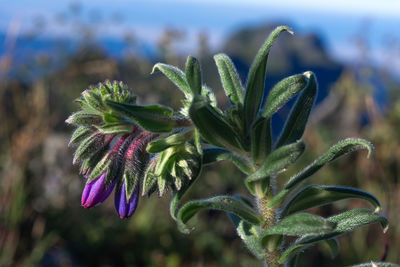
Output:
(257, 189), (281, 267)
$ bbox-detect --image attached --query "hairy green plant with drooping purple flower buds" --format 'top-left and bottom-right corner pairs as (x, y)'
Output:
(66, 26), (395, 267)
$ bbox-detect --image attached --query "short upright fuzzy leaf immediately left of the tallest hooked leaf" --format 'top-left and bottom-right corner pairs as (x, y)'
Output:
(214, 54), (244, 105)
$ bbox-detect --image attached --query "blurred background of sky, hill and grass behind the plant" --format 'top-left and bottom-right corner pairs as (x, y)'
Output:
(0, 0), (400, 267)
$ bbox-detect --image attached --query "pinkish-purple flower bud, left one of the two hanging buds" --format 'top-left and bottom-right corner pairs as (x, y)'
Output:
(81, 172), (115, 209)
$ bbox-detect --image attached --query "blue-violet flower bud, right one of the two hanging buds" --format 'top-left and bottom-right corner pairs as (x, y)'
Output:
(115, 181), (139, 219)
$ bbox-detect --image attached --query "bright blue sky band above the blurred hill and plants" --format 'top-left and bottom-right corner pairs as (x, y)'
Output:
(0, 0), (400, 73)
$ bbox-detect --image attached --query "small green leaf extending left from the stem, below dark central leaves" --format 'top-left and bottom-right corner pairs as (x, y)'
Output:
(203, 147), (254, 175)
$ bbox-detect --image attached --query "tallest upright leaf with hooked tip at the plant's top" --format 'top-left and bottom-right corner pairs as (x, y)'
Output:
(243, 26), (292, 132)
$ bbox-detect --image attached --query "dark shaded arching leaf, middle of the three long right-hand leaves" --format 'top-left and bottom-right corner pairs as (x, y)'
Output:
(282, 185), (381, 217)
